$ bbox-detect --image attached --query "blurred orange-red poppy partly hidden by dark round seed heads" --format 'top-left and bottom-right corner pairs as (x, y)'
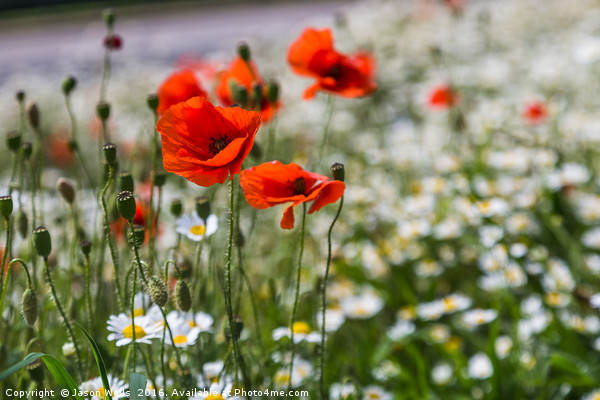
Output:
(217, 56), (280, 122)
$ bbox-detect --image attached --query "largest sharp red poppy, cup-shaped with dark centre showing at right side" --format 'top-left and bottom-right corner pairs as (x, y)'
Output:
(156, 97), (260, 186)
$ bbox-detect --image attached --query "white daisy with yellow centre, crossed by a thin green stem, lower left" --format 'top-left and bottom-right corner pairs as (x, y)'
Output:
(107, 314), (162, 347)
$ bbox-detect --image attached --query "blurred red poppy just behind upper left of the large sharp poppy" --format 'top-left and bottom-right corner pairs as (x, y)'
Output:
(157, 69), (208, 114)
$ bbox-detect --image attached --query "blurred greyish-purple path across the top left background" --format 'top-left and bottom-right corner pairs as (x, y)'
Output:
(0, 0), (349, 78)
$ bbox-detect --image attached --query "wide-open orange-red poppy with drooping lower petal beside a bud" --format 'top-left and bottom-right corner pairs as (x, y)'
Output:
(240, 161), (346, 229)
